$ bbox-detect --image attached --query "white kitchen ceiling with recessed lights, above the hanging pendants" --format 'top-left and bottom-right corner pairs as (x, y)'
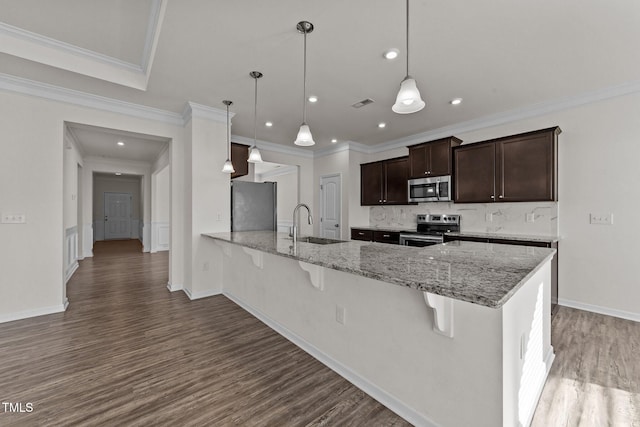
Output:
(0, 0), (640, 149)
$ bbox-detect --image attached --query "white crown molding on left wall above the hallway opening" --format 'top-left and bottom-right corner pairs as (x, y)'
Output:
(0, 74), (184, 126)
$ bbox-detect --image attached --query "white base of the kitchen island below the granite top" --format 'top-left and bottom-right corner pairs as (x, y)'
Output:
(215, 241), (553, 427)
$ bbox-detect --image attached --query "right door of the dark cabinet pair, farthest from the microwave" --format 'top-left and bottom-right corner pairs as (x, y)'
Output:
(496, 133), (555, 202)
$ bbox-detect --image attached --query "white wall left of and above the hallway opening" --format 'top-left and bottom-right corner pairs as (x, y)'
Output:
(0, 91), (184, 321)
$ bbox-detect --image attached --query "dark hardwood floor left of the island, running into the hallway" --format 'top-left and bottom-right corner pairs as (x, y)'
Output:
(0, 241), (409, 426)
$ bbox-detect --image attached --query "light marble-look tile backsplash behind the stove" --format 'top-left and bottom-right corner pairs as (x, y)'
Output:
(369, 202), (558, 236)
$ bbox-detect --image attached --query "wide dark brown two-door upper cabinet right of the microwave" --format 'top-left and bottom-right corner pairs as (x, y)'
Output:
(453, 127), (561, 203)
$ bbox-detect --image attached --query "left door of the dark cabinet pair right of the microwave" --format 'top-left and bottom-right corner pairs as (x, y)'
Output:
(453, 144), (496, 203)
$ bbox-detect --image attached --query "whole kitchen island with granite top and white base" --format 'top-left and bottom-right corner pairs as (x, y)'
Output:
(205, 232), (554, 426)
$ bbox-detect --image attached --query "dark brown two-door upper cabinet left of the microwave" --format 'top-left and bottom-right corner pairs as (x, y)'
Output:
(360, 157), (409, 206)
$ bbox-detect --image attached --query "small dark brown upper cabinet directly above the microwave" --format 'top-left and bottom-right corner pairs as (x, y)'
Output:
(409, 136), (462, 178)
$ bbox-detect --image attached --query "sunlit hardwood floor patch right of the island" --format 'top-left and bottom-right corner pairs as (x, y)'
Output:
(531, 307), (640, 427)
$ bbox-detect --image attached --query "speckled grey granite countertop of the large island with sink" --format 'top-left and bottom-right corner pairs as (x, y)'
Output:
(203, 231), (555, 308)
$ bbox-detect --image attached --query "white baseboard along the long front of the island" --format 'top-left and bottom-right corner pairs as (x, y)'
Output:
(222, 292), (437, 427)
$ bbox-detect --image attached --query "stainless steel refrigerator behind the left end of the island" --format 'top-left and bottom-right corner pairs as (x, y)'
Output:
(231, 181), (278, 231)
